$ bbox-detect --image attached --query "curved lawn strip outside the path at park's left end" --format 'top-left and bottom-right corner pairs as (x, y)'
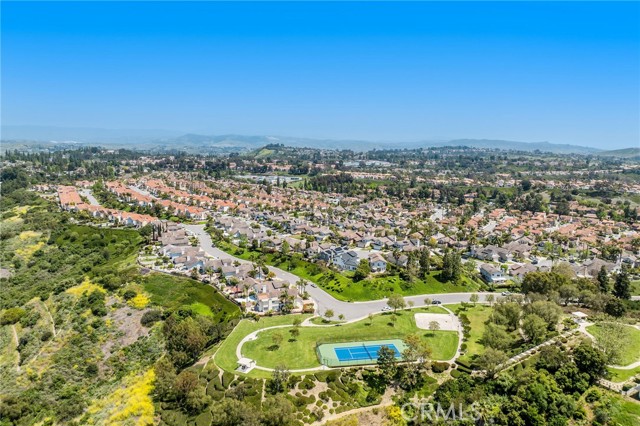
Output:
(214, 315), (310, 377)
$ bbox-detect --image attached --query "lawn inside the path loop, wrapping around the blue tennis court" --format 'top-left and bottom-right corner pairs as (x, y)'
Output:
(242, 311), (458, 369)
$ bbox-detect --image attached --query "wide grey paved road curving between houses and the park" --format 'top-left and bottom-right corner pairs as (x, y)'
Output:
(185, 225), (500, 321)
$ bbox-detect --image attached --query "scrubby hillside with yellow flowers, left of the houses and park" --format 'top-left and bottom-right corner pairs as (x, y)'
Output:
(0, 197), (240, 425)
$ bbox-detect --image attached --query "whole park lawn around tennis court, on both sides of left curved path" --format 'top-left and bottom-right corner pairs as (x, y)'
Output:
(215, 307), (458, 373)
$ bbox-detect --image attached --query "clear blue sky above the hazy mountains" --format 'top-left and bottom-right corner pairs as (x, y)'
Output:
(1, 1), (640, 148)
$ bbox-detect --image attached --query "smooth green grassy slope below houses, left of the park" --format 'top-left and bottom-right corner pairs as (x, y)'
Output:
(142, 273), (240, 318)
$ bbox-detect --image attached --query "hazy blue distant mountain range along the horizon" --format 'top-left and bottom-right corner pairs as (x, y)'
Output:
(1, 125), (640, 158)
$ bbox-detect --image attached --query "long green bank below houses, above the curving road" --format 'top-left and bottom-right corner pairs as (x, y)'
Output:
(216, 238), (480, 302)
